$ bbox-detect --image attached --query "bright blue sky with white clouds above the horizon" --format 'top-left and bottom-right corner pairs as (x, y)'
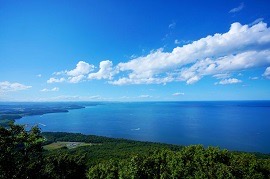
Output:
(0, 0), (270, 101)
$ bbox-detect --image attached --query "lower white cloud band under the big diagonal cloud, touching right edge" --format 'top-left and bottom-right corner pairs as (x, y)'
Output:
(179, 50), (270, 84)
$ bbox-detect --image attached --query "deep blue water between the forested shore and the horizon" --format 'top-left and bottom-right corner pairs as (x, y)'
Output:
(17, 101), (270, 153)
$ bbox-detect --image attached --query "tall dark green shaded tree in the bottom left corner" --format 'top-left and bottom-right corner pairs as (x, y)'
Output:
(0, 124), (43, 179)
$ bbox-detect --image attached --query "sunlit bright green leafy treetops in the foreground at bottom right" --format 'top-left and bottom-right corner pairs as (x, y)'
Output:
(87, 145), (270, 178)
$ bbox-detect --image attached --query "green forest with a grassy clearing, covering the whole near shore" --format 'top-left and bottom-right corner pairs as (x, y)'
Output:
(0, 124), (270, 179)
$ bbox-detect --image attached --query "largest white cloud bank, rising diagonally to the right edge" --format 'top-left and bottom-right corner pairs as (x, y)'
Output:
(109, 22), (270, 85)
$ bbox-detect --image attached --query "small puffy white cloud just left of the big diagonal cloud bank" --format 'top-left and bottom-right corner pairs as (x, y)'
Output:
(88, 60), (115, 80)
